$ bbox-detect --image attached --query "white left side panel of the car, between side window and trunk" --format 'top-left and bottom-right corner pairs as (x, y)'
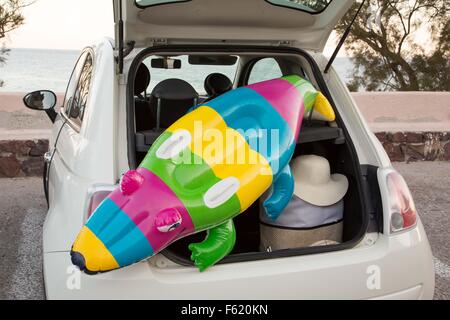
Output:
(44, 39), (118, 252)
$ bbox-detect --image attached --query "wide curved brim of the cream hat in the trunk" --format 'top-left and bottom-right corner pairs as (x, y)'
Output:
(294, 174), (349, 207)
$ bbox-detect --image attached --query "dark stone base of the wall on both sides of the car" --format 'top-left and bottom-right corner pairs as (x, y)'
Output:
(0, 132), (450, 178)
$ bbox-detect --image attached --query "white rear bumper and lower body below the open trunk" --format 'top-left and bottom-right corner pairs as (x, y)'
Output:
(44, 219), (434, 300)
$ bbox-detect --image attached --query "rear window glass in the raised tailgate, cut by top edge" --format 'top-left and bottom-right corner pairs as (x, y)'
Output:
(135, 0), (333, 13)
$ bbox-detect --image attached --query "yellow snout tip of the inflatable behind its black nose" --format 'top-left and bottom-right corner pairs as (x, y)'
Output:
(72, 227), (120, 272)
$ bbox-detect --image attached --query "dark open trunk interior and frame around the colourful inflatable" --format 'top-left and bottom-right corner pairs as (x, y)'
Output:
(128, 46), (376, 265)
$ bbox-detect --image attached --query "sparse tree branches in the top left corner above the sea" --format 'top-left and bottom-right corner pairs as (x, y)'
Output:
(0, 0), (31, 87)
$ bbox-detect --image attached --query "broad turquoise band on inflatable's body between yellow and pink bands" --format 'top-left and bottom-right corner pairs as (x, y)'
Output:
(206, 88), (295, 176)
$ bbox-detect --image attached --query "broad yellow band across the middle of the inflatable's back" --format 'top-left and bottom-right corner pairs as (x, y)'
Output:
(168, 106), (273, 211)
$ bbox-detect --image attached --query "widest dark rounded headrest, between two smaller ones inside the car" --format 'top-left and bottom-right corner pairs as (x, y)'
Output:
(152, 79), (198, 100)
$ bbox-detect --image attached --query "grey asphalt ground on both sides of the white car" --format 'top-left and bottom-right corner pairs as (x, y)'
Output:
(0, 162), (450, 300)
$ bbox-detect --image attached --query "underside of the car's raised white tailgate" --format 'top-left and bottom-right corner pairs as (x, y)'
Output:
(114, 0), (354, 51)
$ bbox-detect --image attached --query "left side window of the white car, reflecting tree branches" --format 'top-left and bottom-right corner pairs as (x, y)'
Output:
(64, 51), (93, 127)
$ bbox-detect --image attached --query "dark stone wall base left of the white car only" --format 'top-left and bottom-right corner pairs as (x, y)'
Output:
(0, 140), (49, 178)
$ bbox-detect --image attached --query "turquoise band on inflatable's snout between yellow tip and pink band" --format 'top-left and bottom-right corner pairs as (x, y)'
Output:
(87, 199), (154, 267)
